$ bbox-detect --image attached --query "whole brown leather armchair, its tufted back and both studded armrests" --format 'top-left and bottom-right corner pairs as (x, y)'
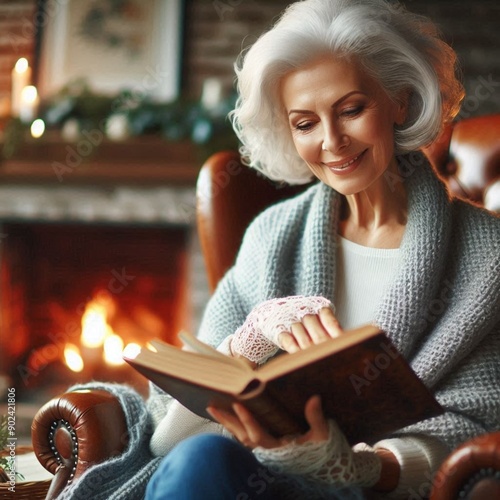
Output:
(32, 116), (500, 500)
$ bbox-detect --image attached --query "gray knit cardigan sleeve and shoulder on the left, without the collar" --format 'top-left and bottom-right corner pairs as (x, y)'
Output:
(198, 186), (316, 347)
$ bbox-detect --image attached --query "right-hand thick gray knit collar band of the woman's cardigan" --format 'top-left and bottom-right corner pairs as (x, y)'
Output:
(375, 153), (452, 357)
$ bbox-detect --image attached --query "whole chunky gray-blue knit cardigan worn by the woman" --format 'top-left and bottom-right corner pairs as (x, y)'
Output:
(57, 155), (500, 500)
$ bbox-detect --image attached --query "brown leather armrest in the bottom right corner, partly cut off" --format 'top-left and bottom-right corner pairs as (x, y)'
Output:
(430, 432), (500, 500)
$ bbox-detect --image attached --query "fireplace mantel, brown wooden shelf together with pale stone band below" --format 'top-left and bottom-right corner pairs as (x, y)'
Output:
(0, 135), (203, 225)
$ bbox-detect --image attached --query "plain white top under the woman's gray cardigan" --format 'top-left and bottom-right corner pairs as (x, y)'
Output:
(335, 236), (400, 330)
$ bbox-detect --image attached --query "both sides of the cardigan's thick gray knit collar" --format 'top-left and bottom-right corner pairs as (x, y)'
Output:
(298, 153), (451, 356)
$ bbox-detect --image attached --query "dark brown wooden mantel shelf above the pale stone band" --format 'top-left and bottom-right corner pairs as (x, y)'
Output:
(0, 136), (206, 185)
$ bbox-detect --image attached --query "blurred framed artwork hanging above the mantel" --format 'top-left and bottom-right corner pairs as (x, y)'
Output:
(37, 0), (183, 101)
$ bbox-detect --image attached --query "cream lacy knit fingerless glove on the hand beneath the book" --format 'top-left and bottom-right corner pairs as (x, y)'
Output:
(253, 420), (381, 487)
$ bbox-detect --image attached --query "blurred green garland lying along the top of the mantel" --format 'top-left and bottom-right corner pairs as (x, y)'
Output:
(2, 80), (238, 158)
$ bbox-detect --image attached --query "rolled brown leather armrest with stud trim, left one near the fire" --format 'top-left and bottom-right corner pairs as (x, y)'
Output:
(31, 390), (128, 499)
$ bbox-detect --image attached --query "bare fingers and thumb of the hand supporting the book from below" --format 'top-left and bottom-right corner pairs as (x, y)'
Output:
(207, 396), (328, 449)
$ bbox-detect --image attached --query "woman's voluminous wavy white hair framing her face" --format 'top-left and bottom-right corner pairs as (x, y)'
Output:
(230, 0), (463, 184)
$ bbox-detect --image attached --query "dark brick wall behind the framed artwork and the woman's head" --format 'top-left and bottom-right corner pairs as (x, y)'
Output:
(0, 0), (500, 116)
